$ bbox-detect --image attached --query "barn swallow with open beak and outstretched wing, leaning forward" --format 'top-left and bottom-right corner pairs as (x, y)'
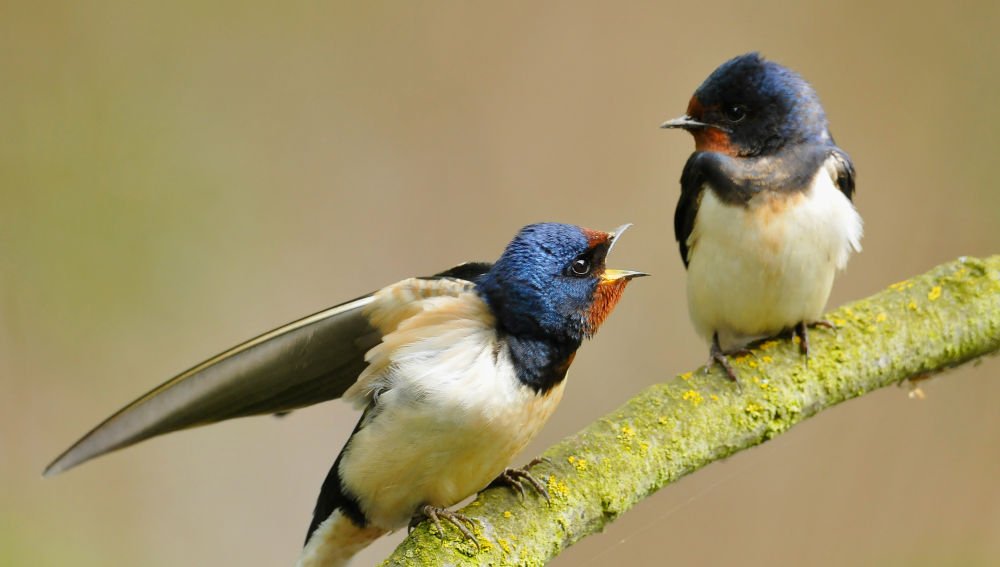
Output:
(45, 223), (646, 567)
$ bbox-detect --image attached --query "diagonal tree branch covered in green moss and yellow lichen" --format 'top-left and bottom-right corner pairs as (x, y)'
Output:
(383, 256), (1000, 566)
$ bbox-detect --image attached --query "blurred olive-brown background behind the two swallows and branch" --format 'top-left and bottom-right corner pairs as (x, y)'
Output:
(0, 0), (1000, 566)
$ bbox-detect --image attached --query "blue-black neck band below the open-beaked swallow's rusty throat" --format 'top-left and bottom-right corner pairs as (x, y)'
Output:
(505, 335), (580, 394)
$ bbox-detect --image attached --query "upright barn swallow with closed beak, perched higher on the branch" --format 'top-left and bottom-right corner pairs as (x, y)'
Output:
(661, 53), (862, 380)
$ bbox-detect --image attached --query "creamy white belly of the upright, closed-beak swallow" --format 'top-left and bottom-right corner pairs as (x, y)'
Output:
(687, 155), (862, 351)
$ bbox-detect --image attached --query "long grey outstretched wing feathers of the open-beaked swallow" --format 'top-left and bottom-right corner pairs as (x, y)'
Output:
(45, 263), (490, 476)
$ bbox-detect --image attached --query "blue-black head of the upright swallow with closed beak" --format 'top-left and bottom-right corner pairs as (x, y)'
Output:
(661, 53), (832, 157)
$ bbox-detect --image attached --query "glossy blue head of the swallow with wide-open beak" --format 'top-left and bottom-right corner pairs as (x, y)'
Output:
(477, 223), (647, 345)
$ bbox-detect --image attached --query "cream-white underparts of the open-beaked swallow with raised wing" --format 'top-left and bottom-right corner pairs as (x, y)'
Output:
(300, 280), (565, 567)
